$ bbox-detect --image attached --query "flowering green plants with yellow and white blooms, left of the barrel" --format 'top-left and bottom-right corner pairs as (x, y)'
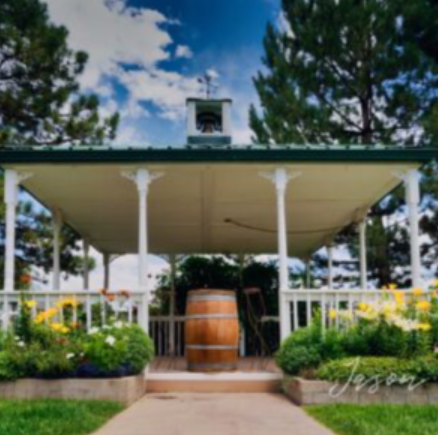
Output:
(0, 297), (154, 381)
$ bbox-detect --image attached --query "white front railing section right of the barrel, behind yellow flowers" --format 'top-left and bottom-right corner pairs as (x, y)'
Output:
(281, 289), (430, 339)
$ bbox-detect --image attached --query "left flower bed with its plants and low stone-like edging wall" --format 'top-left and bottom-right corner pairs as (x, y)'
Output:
(0, 299), (154, 403)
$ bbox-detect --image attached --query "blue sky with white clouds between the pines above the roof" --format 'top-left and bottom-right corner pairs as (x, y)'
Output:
(47, 0), (280, 146)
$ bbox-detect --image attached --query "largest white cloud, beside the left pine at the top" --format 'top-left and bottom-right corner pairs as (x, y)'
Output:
(43, 0), (204, 120)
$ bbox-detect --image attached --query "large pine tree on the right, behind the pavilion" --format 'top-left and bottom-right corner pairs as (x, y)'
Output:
(250, 0), (438, 285)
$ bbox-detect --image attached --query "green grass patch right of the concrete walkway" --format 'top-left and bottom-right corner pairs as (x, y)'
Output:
(306, 405), (438, 435)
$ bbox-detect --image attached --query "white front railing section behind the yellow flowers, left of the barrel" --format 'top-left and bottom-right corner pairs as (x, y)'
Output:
(0, 290), (146, 330)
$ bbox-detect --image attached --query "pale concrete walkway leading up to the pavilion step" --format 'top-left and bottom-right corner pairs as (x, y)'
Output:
(91, 393), (333, 435)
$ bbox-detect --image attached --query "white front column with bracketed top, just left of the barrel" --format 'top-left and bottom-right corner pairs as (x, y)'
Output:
(122, 168), (162, 332)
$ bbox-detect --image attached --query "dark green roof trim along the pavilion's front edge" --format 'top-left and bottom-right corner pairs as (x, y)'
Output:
(0, 147), (438, 165)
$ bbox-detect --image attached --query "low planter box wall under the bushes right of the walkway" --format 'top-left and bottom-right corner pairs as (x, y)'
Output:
(283, 377), (438, 405)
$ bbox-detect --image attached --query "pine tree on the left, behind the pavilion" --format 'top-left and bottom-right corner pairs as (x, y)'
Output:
(0, 0), (118, 287)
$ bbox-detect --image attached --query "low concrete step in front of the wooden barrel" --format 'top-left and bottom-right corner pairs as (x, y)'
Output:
(146, 372), (282, 393)
